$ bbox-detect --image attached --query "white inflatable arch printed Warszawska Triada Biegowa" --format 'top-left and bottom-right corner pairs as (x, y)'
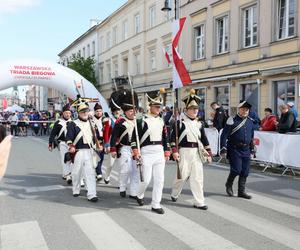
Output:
(0, 59), (109, 113)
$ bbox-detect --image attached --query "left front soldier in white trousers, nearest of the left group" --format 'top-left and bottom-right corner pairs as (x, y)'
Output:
(66, 102), (99, 202)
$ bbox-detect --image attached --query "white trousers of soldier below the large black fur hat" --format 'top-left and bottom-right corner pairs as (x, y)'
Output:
(118, 146), (139, 196)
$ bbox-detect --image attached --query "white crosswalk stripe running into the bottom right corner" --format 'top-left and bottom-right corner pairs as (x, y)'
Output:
(188, 198), (300, 249)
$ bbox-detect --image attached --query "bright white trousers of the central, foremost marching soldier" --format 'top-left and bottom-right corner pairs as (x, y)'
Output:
(137, 145), (166, 208)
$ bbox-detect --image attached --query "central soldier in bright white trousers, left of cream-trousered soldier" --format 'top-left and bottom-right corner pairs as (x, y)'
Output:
(131, 89), (170, 214)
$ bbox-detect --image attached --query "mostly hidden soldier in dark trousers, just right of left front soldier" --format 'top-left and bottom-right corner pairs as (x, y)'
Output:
(93, 103), (104, 181)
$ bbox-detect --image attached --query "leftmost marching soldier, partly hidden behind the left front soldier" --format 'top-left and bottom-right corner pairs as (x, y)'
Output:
(48, 104), (72, 184)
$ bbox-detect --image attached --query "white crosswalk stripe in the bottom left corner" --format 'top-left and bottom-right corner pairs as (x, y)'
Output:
(0, 221), (48, 250)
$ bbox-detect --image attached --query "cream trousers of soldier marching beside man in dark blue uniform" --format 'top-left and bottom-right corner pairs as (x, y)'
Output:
(171, 148), (205, 206)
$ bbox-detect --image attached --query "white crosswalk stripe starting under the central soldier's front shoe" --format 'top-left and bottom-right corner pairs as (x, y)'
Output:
(138, 206), (243, 250)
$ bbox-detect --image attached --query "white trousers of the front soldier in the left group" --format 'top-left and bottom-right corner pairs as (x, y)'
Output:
(72, 149), (97, 199)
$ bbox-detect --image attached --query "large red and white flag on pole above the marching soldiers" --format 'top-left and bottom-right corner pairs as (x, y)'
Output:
(172, 17), (192, 89)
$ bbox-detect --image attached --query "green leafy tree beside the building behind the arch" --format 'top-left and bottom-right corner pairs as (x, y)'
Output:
(68, 54), (99, 88)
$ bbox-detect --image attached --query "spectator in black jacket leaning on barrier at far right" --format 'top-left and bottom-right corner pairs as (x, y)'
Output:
(276, 104), (297, 134)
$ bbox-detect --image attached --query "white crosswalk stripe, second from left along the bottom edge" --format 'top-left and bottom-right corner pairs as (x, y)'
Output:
(72, 212), (145, 250)
